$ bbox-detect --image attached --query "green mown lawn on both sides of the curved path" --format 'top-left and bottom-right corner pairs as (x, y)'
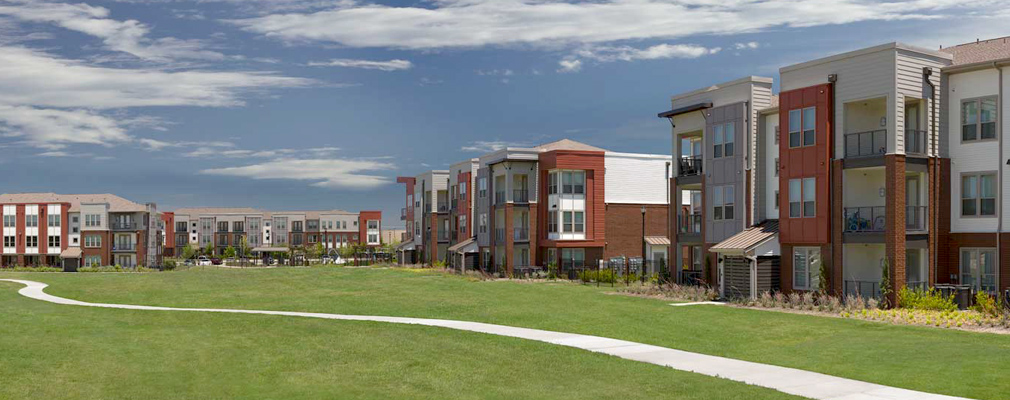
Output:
(0, 268), (1010, 399)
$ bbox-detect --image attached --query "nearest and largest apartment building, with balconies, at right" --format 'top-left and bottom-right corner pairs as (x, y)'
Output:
(660, 38), (1010, 297)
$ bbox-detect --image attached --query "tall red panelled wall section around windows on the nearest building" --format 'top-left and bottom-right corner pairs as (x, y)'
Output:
(779, 84), (833, 243)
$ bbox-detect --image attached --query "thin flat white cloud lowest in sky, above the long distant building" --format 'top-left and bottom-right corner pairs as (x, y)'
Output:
(200, 158), (394, 189)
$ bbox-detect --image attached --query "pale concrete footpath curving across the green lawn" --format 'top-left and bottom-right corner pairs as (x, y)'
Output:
(0, 279), (963, 400)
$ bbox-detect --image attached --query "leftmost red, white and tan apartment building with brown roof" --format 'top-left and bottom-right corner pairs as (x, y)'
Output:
(0, 193), (164, 271)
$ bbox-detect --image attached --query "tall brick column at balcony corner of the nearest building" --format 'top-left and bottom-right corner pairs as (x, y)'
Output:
(884, 155), (906, 304)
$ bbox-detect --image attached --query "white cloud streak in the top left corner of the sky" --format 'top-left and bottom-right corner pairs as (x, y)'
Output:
(0, 0), (225, 62)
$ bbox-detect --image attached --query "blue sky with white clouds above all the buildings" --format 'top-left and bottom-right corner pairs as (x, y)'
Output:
(0, 0), (1010, 226)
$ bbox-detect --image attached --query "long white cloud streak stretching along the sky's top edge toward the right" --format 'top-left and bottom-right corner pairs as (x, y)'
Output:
(228, 0), (985, 49)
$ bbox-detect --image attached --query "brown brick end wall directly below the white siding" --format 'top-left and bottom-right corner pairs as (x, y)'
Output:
(603, 204), (669, 260)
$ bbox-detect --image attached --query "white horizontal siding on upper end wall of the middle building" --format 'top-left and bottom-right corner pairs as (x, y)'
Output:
(605, 153), (673, 204)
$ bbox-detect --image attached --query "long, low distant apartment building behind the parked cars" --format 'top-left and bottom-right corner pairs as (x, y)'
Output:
(167, 208), (383, 255)
